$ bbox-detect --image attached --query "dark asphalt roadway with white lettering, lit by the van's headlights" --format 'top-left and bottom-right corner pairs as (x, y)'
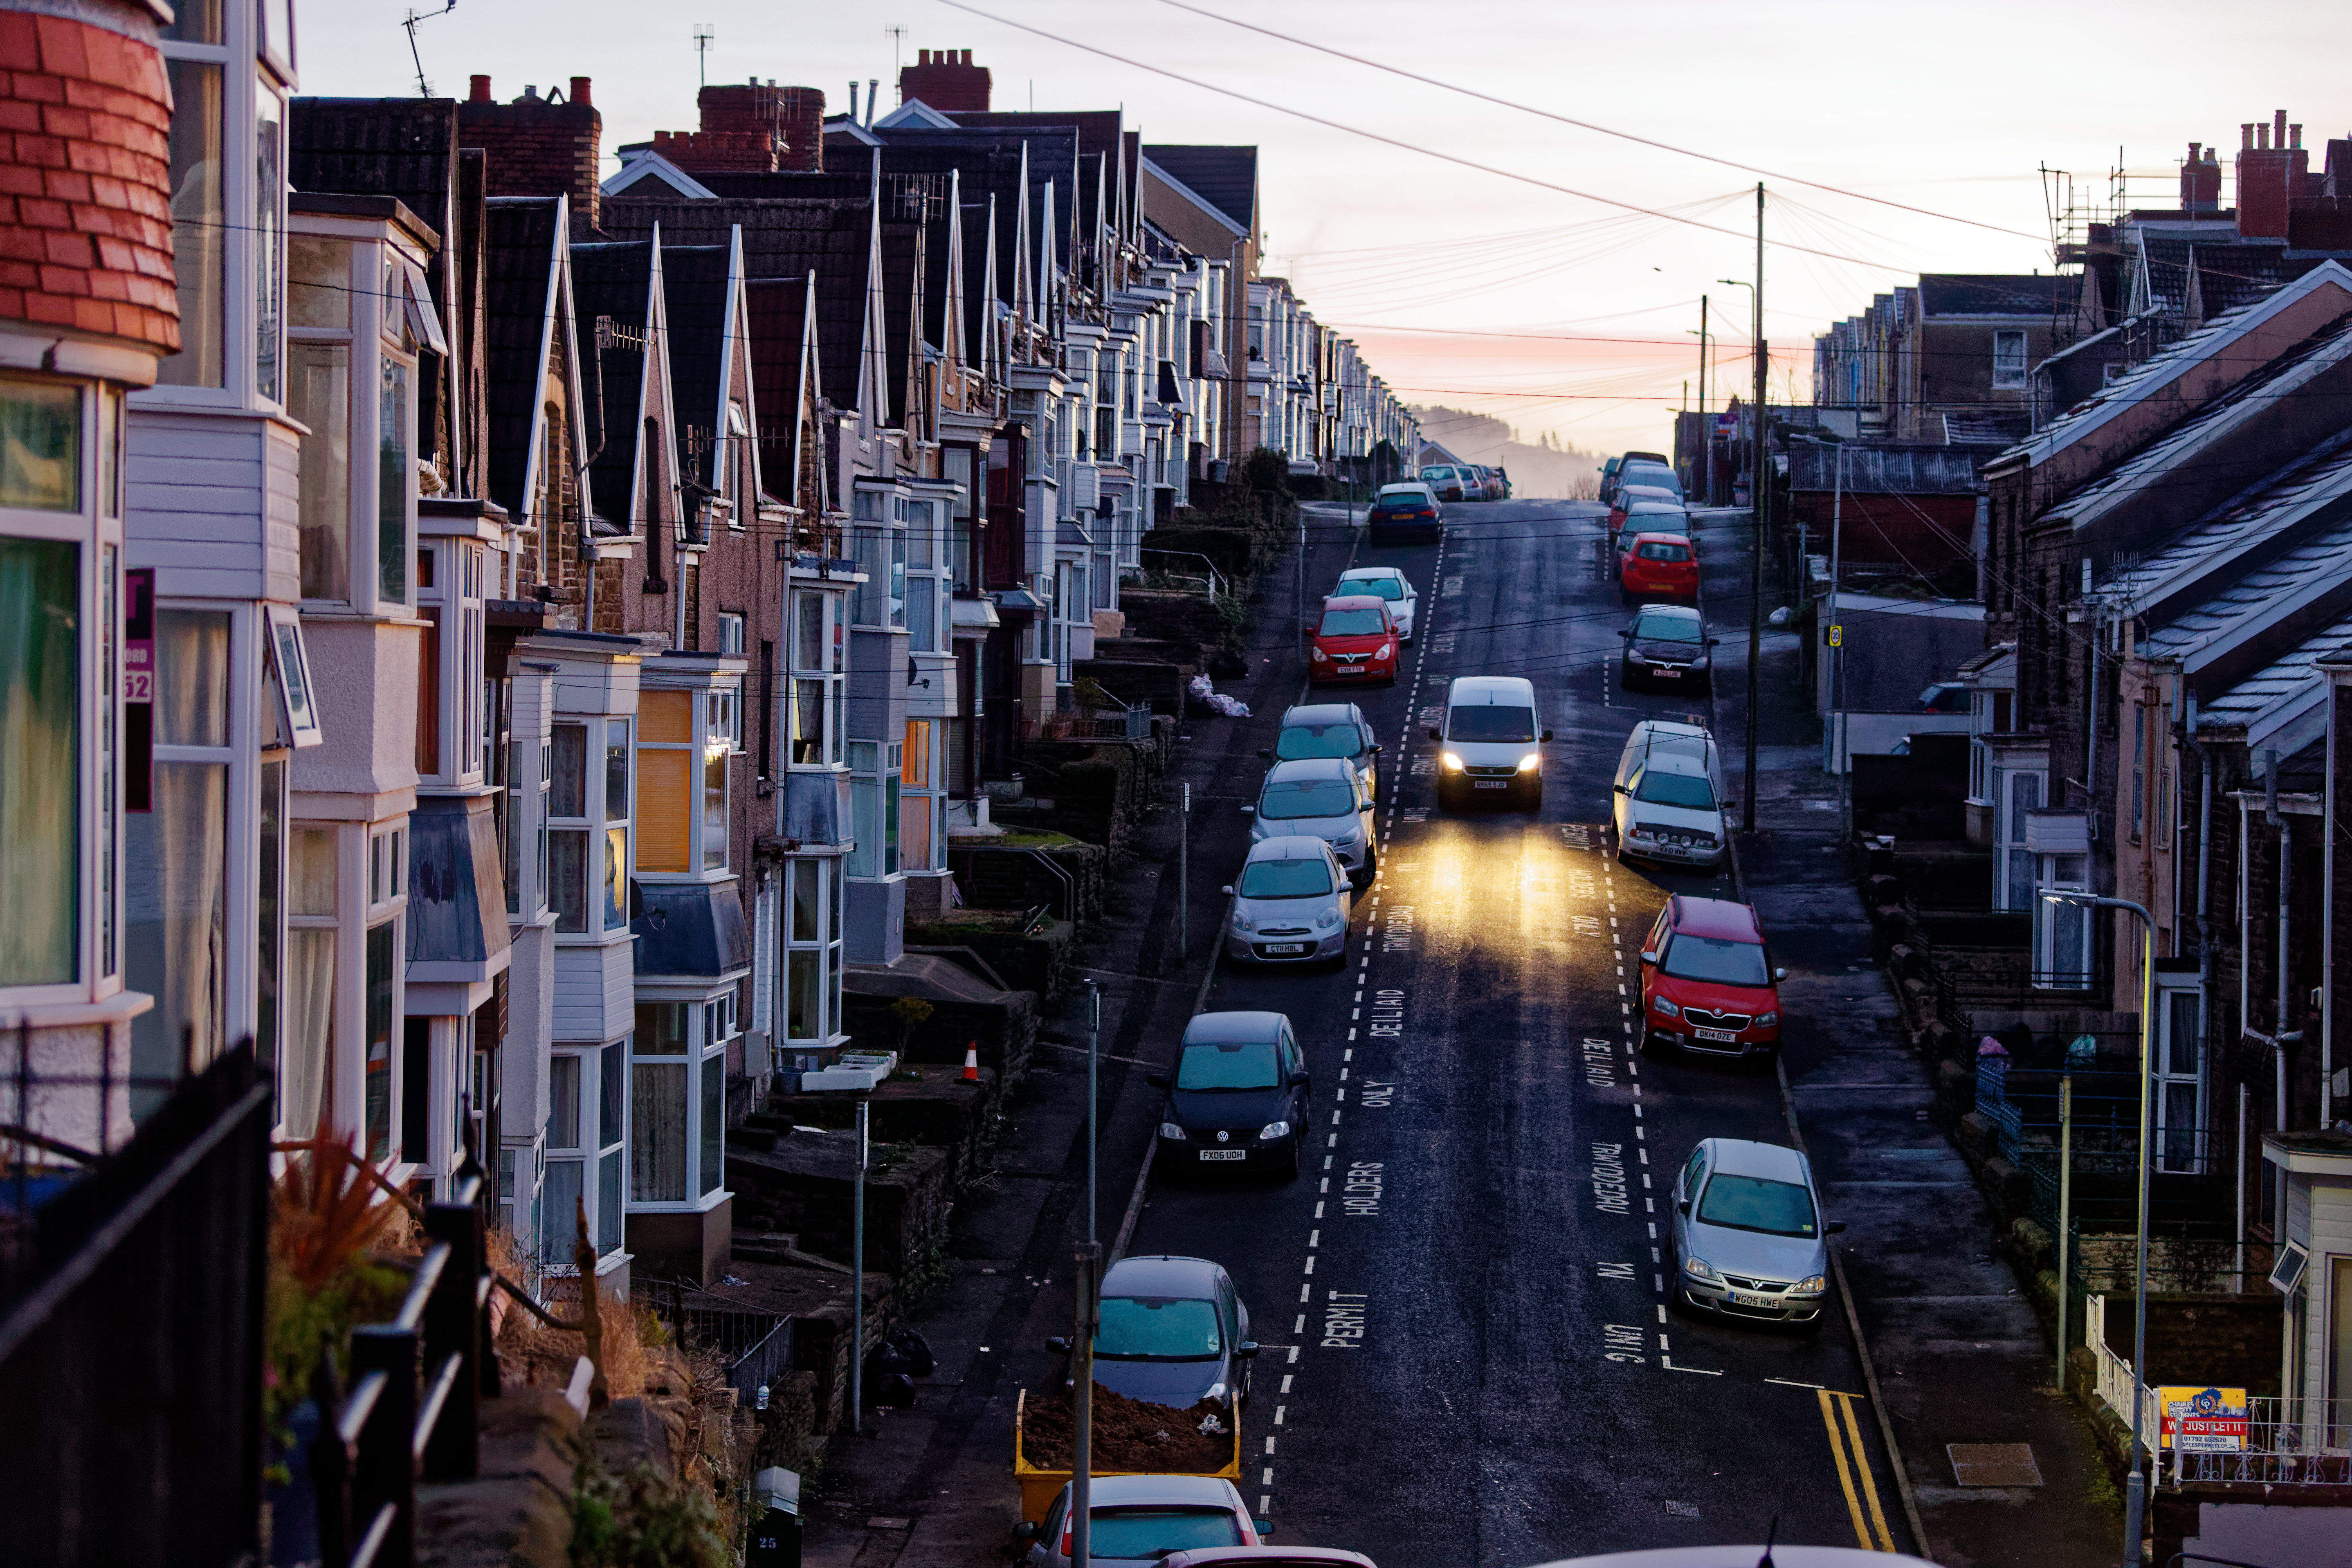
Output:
(1129, 501), (1910, 1568)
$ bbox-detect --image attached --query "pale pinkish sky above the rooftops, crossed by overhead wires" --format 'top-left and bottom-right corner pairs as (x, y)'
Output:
(301, 0), (2352, 452)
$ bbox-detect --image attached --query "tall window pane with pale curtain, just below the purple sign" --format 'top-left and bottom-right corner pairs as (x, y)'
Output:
(122, 762), (228, 1103)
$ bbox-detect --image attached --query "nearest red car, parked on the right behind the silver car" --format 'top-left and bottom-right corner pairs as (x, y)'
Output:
(1642, 893), (1788, 1063)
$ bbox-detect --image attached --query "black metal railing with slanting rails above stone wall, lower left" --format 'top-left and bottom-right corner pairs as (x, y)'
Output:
(310, 1157), (499, 1568)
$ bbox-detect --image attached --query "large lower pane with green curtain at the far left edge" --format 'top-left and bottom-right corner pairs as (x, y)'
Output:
(0, 538), (77, 985)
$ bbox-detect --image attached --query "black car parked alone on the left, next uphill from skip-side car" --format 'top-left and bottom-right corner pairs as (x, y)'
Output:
(1152, 1011), (1317, 1178)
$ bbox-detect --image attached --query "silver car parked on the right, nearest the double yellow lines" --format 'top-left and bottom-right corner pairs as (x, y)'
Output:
(1672, 1138), (1847, 1328)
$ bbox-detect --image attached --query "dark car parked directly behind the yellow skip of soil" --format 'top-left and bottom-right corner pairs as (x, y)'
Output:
(1047, 1255), (1258, 1410)
